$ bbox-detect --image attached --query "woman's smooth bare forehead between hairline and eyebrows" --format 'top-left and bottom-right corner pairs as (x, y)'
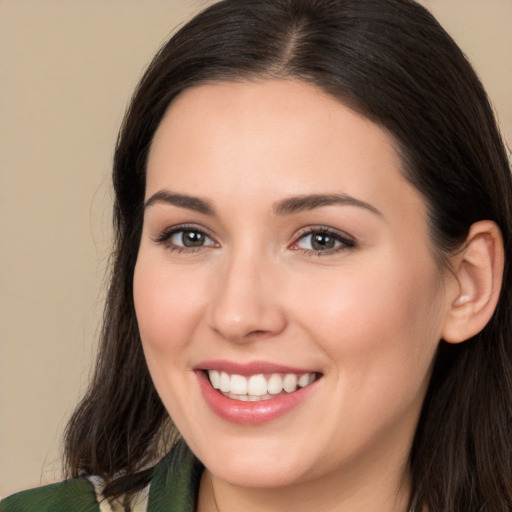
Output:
(146, 80), (423, 222)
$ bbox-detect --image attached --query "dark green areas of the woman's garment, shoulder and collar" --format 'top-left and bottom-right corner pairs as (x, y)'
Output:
(0, 441), (203, 512)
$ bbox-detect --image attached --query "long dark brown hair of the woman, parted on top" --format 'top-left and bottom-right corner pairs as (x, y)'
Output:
(65, 0), (512, 512)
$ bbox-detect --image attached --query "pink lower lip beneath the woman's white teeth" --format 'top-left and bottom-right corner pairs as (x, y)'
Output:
(196, 371), (317, 425)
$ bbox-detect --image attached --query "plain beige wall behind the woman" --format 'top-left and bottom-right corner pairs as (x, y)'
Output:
(0, 0), (512, 496)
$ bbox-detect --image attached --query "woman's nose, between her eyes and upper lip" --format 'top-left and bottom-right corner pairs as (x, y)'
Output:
(210, 250), (287, 343)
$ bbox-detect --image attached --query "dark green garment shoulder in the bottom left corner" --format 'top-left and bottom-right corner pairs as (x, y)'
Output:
(0, 478), (100, 512)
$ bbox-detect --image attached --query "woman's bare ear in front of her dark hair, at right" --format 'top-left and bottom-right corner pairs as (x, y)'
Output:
(442, 220), (504, 343)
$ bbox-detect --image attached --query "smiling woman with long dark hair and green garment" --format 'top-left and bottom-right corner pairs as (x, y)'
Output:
(0, 0), (512, 512)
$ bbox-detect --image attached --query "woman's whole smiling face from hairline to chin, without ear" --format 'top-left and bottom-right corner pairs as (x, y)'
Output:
(134, 81), (447, 487)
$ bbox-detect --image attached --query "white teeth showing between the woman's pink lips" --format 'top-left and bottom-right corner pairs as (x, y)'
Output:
(205, 370), (320, 402)
